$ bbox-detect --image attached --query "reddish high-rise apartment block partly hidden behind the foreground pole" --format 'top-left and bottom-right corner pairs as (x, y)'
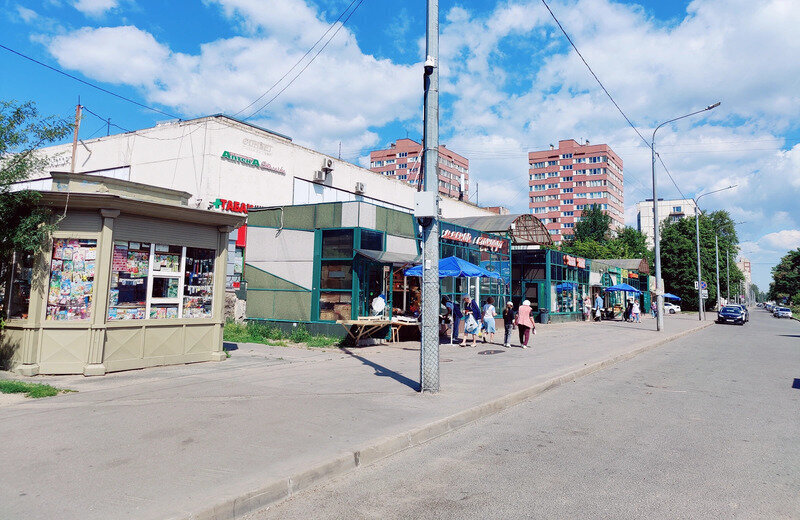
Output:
(369, 139), (469, 200)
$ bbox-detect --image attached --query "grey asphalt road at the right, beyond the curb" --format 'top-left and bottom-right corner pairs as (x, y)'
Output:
(248, 309), (800, 520)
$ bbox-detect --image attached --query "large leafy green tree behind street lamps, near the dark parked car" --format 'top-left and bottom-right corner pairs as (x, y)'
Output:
(661, 210), (744, 309)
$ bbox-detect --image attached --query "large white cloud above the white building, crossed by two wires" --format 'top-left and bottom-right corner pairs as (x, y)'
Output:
(49, 0), (421, 150)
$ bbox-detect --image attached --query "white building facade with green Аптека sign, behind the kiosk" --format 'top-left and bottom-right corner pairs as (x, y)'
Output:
(25, 115), (492, 287)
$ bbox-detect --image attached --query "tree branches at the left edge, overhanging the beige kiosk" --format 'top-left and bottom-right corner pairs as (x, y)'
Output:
(0, 101), (72, 266)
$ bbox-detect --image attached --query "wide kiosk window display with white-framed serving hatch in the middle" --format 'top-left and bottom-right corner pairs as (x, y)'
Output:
(108, 241), (214, 320)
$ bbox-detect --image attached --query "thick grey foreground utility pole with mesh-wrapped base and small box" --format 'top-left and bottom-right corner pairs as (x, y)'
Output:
(419, 0), (439, 392)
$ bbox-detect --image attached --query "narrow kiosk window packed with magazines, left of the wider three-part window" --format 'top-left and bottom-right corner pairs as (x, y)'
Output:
(46, 238), (97, 321)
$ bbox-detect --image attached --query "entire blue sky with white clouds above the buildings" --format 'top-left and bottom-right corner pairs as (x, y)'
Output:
(0, 0), (800, 288)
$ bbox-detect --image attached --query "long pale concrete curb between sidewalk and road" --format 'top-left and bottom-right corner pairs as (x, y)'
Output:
(186, 322), (714, 520)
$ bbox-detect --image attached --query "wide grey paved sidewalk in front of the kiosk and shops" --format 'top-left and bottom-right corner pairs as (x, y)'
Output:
(0, 315), (712, 520)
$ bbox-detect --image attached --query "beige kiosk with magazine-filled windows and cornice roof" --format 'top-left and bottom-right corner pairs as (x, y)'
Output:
(2, 173), (243, 375)
